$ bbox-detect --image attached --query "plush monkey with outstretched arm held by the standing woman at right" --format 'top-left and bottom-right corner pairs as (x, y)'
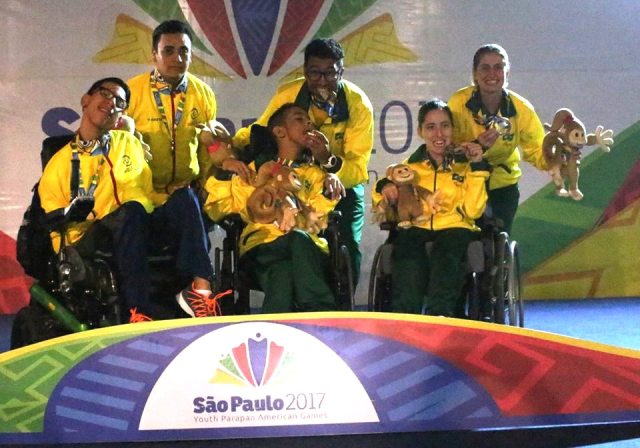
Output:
(542, 109), (613, 201)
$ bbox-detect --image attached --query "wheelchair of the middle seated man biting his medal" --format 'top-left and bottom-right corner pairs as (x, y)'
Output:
(214, 212), (355, 315)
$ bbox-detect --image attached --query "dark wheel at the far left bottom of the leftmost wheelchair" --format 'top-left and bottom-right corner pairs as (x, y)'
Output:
(10, 300), (69, 350)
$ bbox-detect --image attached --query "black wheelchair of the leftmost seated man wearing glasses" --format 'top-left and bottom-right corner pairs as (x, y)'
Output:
(10, 135), (188, 349)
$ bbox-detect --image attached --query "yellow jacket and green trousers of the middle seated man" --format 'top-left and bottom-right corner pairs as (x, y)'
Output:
(204, 160), (336, 313)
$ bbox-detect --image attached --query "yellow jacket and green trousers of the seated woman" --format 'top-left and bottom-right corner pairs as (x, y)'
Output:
(372, 145), (489, 317)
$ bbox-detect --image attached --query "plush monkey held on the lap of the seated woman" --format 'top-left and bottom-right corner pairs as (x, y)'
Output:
(374, 163), (440, 228)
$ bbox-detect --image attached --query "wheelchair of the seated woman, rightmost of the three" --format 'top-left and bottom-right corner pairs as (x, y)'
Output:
(368, 219), (524, 327)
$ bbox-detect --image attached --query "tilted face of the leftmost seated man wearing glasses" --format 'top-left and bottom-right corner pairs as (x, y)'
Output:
(80, 82), (126, 132)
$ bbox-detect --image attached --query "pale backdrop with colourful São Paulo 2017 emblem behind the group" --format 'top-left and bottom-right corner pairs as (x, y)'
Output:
(0, 0), (640, 312)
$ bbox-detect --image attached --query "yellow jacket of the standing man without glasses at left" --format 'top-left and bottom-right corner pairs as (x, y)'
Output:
(127, 72), (216, 205)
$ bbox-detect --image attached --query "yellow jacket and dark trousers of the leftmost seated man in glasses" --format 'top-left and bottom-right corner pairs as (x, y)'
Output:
(38, 131), (153, 321)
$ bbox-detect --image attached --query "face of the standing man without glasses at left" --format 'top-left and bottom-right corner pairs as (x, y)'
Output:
(153, 33), (191, 86)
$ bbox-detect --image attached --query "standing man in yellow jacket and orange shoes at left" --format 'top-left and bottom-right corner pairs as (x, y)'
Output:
(128, 20), (224, 317)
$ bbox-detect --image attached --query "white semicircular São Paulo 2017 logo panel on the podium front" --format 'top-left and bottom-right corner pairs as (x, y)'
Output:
(140, 322), (378, 429)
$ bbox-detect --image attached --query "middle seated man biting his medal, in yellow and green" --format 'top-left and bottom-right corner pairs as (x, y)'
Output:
(205, 103), (345, 313)
